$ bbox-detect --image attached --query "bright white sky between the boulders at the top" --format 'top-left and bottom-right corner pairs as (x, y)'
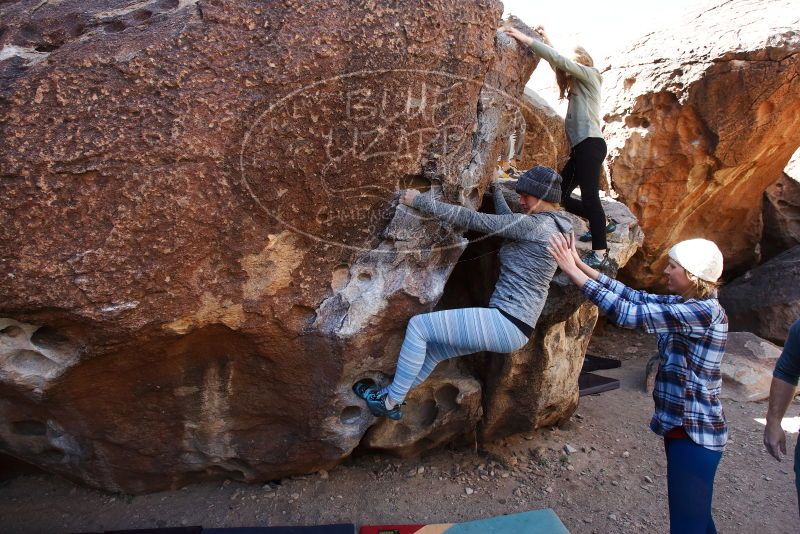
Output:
(503, 0), (708, 115)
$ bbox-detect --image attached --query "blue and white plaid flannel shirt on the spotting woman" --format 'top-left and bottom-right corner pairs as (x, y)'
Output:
(583, 274), (728, 451)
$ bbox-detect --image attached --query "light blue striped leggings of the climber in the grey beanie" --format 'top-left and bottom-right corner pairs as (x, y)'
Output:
(386, 308), (528, 402)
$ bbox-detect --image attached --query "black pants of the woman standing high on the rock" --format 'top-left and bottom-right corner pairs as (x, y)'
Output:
(561, 137), (607, 250)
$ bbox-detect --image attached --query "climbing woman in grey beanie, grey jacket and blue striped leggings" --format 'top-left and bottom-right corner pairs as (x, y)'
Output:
(353, 166), (572, 419)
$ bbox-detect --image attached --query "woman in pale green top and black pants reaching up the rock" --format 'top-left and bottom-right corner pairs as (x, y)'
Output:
(503, 26), (615, 269)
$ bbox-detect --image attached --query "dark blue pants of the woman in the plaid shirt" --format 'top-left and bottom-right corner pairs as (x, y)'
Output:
(664, 438), (722, 534)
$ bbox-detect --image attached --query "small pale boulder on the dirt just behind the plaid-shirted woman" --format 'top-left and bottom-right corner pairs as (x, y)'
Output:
(720, 332), (781, 402)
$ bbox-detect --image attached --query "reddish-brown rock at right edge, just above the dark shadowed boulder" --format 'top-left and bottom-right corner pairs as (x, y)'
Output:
(761, 152), (800, 260)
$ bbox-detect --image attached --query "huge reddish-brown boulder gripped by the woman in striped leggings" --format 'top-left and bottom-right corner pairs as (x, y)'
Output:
(0, 0), (635, 493)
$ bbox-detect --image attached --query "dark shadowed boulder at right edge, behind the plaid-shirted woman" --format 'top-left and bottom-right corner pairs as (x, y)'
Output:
(719, 246), (800, 345)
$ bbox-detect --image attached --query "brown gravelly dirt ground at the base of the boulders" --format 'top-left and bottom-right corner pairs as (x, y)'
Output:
(0, 327), (800, 534)
